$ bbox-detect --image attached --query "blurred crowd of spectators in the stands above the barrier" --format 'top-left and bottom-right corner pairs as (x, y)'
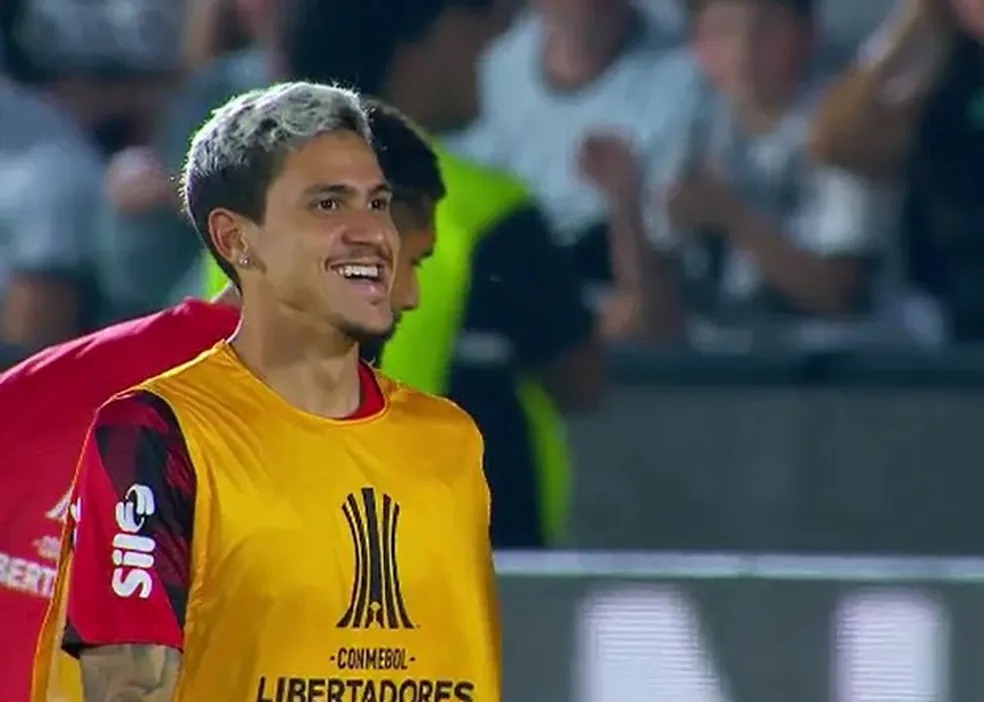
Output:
(0, 0), (984, 353)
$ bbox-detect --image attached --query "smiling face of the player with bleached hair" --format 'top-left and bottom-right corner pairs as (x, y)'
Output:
(244, 132), (400, 340)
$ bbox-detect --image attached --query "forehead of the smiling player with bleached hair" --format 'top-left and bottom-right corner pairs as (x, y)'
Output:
(277, 131), (383, 190)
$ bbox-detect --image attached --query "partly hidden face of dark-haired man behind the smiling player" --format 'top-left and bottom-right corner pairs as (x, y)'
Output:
(390, 201), (436, 328)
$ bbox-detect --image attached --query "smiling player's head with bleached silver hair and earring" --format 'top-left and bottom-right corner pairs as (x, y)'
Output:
(183, 83), (399, 342)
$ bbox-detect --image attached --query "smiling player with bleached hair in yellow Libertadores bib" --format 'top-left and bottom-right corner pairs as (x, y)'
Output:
(33, 83), (499, 702)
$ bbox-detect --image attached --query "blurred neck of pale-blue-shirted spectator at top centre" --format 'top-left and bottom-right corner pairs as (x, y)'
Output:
(542, 5), (635, 90)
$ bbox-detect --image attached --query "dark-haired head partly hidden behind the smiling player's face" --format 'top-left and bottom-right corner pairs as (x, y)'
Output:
(366, 100), (446, 338)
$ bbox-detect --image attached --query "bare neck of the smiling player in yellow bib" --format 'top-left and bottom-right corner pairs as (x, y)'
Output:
(232, 296), (361, 419)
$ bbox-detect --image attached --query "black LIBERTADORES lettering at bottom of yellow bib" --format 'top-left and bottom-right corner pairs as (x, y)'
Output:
(256, 677), (475, 702)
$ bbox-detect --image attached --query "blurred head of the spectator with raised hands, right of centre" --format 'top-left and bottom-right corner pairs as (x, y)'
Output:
(690, 0), (814, 113)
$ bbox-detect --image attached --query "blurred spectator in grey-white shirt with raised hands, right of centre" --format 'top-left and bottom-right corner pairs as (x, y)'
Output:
(584, 0), (891, 346)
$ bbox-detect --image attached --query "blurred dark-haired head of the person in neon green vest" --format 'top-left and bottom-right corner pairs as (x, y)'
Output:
(280, 0), (503, 131)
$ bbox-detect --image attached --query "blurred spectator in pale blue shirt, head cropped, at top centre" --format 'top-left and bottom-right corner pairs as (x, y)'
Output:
(451, 0), (696, 292)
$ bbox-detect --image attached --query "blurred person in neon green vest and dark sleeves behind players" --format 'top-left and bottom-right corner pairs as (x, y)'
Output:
(279, 0), (604, 548)
